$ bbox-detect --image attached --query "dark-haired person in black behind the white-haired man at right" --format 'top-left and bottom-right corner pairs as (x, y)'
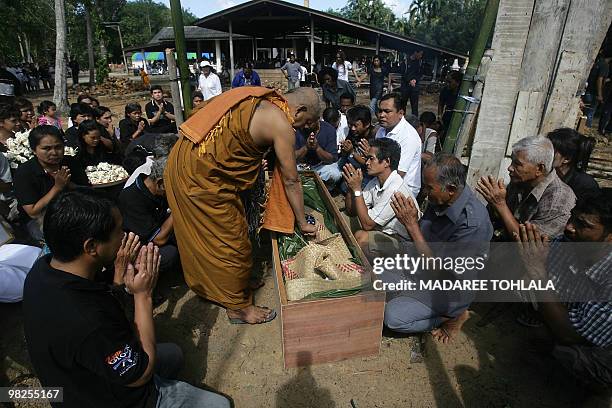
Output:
(546, 128), (599, 199)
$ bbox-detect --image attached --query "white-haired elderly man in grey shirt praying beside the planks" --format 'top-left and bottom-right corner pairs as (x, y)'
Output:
(476, 137), (576, 241)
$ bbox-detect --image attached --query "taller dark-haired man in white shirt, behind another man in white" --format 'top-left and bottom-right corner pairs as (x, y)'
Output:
(370, 92), (422, 197)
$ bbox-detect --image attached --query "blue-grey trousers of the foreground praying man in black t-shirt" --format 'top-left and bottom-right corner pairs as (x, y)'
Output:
(153, 343), (230, 408)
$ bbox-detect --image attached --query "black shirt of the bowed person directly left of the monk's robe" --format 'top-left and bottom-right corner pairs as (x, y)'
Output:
(119, 174), (168, 242)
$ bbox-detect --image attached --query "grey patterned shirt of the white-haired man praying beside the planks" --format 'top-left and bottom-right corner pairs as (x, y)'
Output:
(506, 170), (576, 237)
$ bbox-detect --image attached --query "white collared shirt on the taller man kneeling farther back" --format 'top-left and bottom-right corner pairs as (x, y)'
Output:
(376, 118), (422, 197)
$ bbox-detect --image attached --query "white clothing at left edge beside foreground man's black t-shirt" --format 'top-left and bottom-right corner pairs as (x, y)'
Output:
(0, 244), (41, 303)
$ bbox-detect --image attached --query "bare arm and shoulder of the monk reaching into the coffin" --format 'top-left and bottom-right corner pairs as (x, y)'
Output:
(249, 102), (308, 229)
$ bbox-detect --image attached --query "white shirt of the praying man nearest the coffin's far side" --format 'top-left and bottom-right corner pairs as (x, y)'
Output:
(362, 170), (420, 240)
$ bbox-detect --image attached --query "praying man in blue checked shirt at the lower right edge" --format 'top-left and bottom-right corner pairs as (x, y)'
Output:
(515, 195), (612, 396)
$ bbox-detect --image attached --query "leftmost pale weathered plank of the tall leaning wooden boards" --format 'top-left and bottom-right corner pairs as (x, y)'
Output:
(468, 0), (534, 185)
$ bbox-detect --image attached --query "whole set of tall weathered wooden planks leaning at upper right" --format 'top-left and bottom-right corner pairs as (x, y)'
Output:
(468, 0), (612, 185)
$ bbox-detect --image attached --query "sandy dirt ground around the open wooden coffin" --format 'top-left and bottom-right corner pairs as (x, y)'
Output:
(0, 77), (612, 408)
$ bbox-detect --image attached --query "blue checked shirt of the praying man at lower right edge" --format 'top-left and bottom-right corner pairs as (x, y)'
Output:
(547, 236), (612, 347)
